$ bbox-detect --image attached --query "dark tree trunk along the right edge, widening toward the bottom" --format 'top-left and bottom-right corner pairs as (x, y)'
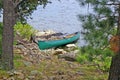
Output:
(108, 4), (120, 80)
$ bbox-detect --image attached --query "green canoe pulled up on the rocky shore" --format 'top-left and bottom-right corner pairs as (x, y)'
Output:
(37, 32), (80, 50)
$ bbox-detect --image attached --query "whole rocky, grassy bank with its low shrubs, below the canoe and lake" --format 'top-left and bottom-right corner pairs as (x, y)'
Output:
(0, 23), (112, 80)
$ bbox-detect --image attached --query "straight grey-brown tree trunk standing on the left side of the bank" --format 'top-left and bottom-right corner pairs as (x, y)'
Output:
(2, 0), (15, 70)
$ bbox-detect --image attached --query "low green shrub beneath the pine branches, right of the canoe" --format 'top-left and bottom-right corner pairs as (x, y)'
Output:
(76, 46), (113, 71)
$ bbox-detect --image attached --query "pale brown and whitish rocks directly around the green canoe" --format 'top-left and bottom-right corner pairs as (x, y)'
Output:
(14, 30), (79, 61)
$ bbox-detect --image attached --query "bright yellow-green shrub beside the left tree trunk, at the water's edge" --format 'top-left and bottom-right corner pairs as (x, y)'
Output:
(14, 22), (35, 40)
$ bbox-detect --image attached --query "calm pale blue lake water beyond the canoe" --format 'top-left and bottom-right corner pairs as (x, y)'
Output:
(28, 0), (88, 46)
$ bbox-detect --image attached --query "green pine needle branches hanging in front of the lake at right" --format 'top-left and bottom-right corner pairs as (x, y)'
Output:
(78, 0), (120, 48)
